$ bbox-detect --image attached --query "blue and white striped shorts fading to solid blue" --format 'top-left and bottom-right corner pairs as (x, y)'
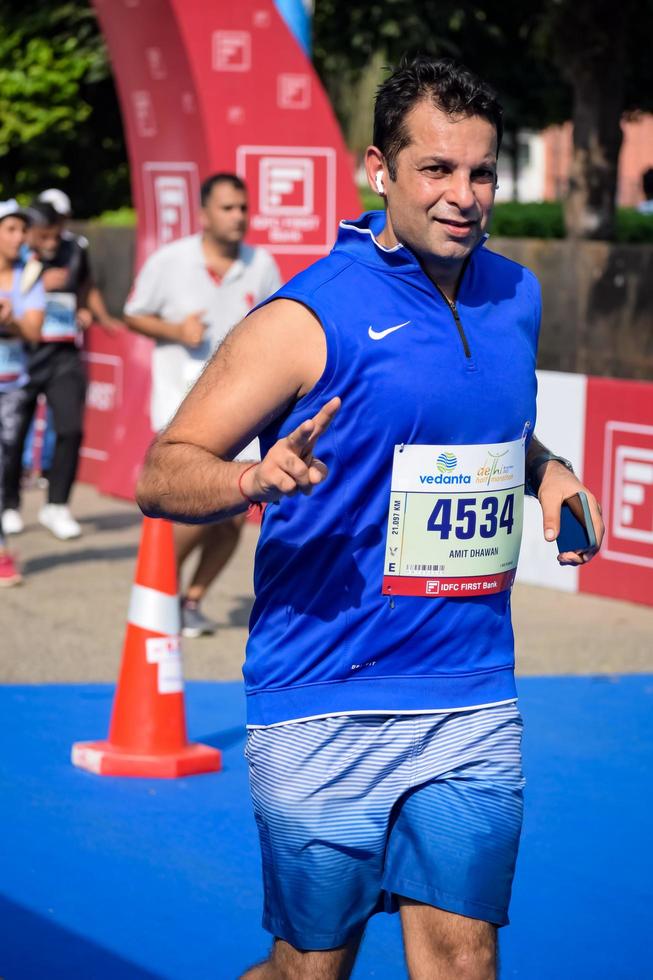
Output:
(246, 703), (524, 950)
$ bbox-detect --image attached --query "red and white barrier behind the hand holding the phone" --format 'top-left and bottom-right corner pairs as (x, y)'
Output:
(517, 371), (653, 605)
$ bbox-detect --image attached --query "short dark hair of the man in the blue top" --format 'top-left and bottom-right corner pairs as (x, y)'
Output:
(373, 55), (503, 180)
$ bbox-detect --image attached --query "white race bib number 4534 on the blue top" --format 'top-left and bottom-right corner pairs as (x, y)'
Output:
(383, 439), (525, 598)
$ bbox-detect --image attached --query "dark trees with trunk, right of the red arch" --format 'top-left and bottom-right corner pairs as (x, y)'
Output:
(315, 0), (653, 238)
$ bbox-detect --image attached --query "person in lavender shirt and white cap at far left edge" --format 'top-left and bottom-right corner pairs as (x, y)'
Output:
(0, 200), (45, 587)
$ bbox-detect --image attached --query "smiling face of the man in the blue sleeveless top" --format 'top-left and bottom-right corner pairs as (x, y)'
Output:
(385, 99), (497, 267)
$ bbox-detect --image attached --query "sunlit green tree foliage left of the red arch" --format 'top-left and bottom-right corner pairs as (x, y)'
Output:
(0, 0), (129, 217)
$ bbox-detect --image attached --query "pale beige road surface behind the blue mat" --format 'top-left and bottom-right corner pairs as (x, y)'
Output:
(0, 486), (653, 684)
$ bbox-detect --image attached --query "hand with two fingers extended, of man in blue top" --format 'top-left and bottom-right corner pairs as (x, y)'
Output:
(241, 398), (341, 502)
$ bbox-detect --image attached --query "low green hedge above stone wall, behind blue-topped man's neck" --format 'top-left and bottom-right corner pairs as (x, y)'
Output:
(359, 187), (653, 244)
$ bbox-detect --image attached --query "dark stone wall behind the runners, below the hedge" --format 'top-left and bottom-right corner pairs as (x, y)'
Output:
(75, 223), (653, 380)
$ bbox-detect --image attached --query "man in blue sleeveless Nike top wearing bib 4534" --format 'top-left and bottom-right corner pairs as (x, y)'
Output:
(138, 58), (602, 980)
